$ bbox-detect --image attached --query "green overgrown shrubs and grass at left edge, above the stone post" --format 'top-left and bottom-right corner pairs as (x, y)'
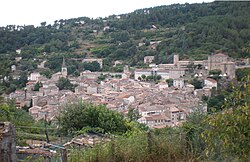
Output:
(0, 98), (56, 146)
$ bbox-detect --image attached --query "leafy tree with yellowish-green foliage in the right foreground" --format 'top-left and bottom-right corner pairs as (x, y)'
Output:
(202, 76), (250, 161)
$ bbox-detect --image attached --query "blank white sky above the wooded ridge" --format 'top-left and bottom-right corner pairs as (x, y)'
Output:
(0, 0), (213, 26)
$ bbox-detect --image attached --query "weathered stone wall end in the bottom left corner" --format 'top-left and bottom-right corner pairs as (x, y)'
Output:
(0, 122), (16, 162)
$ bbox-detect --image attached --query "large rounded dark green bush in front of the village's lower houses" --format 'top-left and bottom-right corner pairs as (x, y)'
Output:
(60, 101), (129, 134)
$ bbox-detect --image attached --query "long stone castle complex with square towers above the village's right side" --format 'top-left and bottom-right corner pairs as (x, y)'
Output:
(135, 53), (235, 80)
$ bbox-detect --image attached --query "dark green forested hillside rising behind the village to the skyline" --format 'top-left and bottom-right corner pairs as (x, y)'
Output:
(0, 2), (250, 91)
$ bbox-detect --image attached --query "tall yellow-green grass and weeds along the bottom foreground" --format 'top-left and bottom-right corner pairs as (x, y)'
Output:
(70, 130), (191, 162)
